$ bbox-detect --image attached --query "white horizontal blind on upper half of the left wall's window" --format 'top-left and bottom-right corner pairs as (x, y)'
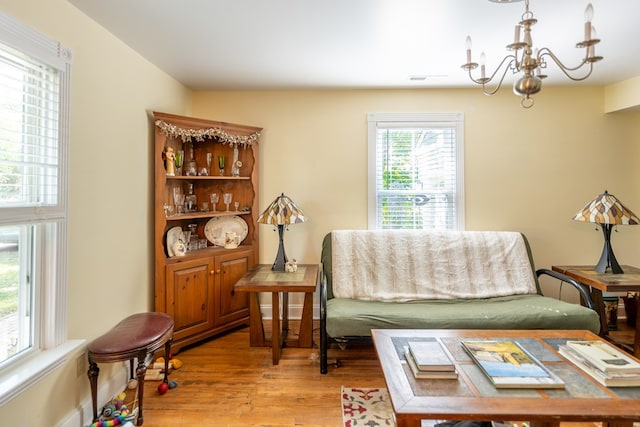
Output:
(0, 45), (60, 208)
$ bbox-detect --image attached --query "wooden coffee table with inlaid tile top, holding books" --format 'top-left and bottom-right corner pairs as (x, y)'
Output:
(371, 329), (640, 427)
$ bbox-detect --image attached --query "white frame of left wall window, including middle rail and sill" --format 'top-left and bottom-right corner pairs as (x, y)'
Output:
(0, 12), (84, 407)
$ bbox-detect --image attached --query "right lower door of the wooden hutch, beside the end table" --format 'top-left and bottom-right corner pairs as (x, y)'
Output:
(214, 249), (254, 325)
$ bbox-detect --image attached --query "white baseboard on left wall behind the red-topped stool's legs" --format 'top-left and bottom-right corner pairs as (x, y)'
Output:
(58, 362), (129, 427)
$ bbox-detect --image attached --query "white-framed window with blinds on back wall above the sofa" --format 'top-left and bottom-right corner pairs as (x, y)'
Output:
(369, 113), (464, 230)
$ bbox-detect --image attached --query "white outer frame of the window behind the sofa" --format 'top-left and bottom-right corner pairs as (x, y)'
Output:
(367, 112), (465, 230)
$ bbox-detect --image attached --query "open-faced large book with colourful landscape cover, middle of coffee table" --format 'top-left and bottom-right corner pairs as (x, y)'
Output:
(461, 340), (564, 388)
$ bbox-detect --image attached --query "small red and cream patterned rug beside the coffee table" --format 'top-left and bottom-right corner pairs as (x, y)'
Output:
(341, 386), (396, 427)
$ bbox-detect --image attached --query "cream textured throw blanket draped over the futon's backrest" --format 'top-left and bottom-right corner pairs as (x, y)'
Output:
(331, 230), (536, 301)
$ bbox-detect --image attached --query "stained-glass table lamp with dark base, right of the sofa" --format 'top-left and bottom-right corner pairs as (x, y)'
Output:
(573, 190), (640, 274)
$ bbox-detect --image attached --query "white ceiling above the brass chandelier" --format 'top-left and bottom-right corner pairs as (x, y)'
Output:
(69, 0), (640, 90)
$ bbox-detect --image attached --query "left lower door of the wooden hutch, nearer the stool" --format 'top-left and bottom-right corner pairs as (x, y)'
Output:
(166, 258), (214, 340)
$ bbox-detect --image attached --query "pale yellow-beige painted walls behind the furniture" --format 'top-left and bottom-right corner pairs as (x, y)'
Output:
(0, 0), (640, 427)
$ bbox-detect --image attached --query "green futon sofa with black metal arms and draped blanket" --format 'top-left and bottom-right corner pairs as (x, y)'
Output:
(320, 230), (600, 374)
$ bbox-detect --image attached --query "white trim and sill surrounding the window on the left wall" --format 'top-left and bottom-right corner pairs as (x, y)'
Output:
(0, 12), (85, 407)
